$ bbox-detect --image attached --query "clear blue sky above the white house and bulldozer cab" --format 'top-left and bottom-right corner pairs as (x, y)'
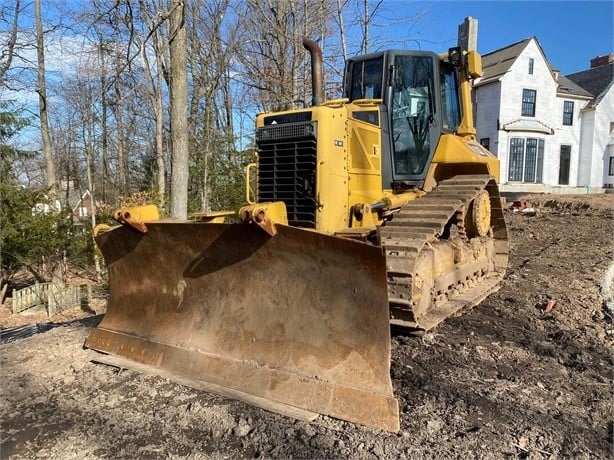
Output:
(382, 0), (614, 75)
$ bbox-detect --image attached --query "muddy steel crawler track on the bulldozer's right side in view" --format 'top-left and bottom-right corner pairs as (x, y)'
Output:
(378, 175), (508, 330)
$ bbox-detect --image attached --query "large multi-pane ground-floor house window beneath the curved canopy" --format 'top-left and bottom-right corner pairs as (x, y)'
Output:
(508, 137), (544, 184)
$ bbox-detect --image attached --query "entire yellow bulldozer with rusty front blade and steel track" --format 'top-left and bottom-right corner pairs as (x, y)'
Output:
(85, 18), (508, 431)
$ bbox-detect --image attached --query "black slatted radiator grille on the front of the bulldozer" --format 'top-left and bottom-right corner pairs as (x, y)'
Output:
(256, 122), (317, 228)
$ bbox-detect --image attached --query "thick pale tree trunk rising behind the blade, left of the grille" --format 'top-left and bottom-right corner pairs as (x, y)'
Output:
(169, 0), (189, 219)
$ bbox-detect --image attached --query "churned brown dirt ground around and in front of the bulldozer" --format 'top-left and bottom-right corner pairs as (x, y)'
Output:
(0, 195), (614, 459)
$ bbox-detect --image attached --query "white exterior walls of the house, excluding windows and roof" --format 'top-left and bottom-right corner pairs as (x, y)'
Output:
(475, 39), (614, 193)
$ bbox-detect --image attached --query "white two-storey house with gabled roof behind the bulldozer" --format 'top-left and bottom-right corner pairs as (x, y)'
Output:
(474, 37), (614, 193)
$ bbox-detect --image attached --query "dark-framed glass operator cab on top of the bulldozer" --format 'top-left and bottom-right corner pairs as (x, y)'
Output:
(343, 51), (461, 190)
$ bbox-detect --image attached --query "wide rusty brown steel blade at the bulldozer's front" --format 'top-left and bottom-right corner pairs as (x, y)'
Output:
(85, 221), (399, 431)
